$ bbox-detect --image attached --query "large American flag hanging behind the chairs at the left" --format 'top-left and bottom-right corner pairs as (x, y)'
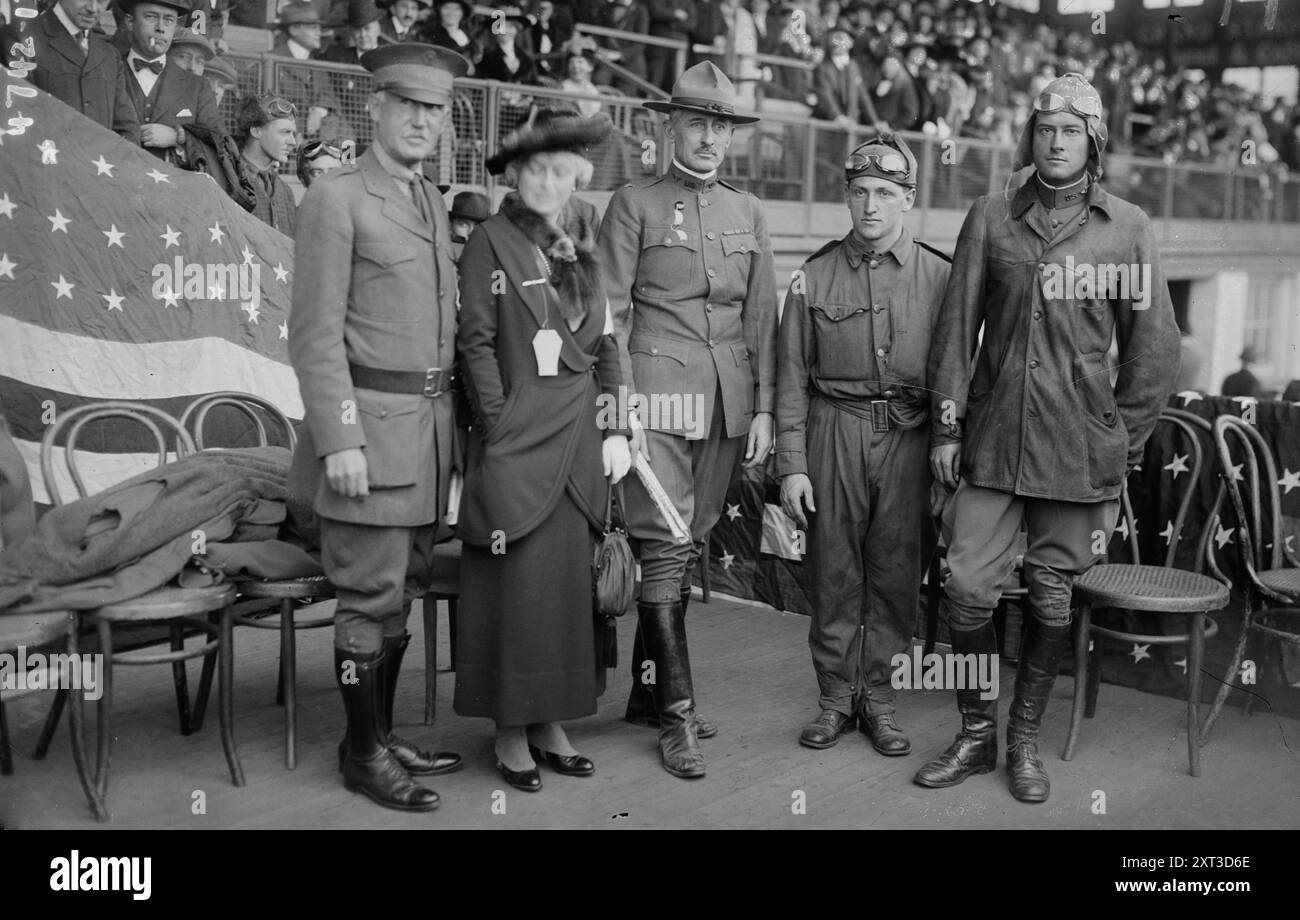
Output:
(0, 70), (303, 503)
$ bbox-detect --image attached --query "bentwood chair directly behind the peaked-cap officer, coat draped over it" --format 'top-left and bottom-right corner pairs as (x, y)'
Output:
(181, 391), (334, 769)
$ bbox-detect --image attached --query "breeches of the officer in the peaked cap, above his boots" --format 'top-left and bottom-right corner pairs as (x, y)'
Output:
(321, 517), (437, 655)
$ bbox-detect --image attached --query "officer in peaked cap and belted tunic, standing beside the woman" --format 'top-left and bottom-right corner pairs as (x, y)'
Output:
(289, 43), (468, 811)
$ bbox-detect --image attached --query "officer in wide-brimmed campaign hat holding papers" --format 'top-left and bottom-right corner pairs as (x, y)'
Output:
(599, 61), (776, 777)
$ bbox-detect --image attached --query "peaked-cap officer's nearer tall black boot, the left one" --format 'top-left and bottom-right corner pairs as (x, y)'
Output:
(334, 648), (439, 811)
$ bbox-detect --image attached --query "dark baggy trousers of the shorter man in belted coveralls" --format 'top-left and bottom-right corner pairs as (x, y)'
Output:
(806, 399), (935, 716)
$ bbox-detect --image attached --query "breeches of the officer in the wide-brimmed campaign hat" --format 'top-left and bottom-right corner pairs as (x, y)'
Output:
(624, 394), (745, 603)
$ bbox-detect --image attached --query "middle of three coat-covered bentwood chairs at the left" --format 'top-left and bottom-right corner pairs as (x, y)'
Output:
(36, 402), (244, 821)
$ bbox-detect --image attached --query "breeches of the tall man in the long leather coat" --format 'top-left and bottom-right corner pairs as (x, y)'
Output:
(944, 479), (1119, 630)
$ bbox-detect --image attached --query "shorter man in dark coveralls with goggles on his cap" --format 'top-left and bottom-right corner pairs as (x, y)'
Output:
(776, 135), (950, 756)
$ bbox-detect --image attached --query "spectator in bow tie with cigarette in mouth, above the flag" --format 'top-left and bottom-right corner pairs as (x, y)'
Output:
(122, 0), (225, 165)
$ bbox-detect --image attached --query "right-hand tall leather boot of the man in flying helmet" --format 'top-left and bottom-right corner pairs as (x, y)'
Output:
(1006, 617), (1070, 802)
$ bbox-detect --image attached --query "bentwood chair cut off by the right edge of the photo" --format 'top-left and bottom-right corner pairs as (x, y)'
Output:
(1200, 416), (1300, 745)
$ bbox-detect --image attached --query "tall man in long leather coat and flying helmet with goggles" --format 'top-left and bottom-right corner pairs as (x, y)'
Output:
(915, 73), (1179, 802)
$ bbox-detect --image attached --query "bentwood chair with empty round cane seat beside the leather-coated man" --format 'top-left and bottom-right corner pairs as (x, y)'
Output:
(1061, 412), (1229, 776)
